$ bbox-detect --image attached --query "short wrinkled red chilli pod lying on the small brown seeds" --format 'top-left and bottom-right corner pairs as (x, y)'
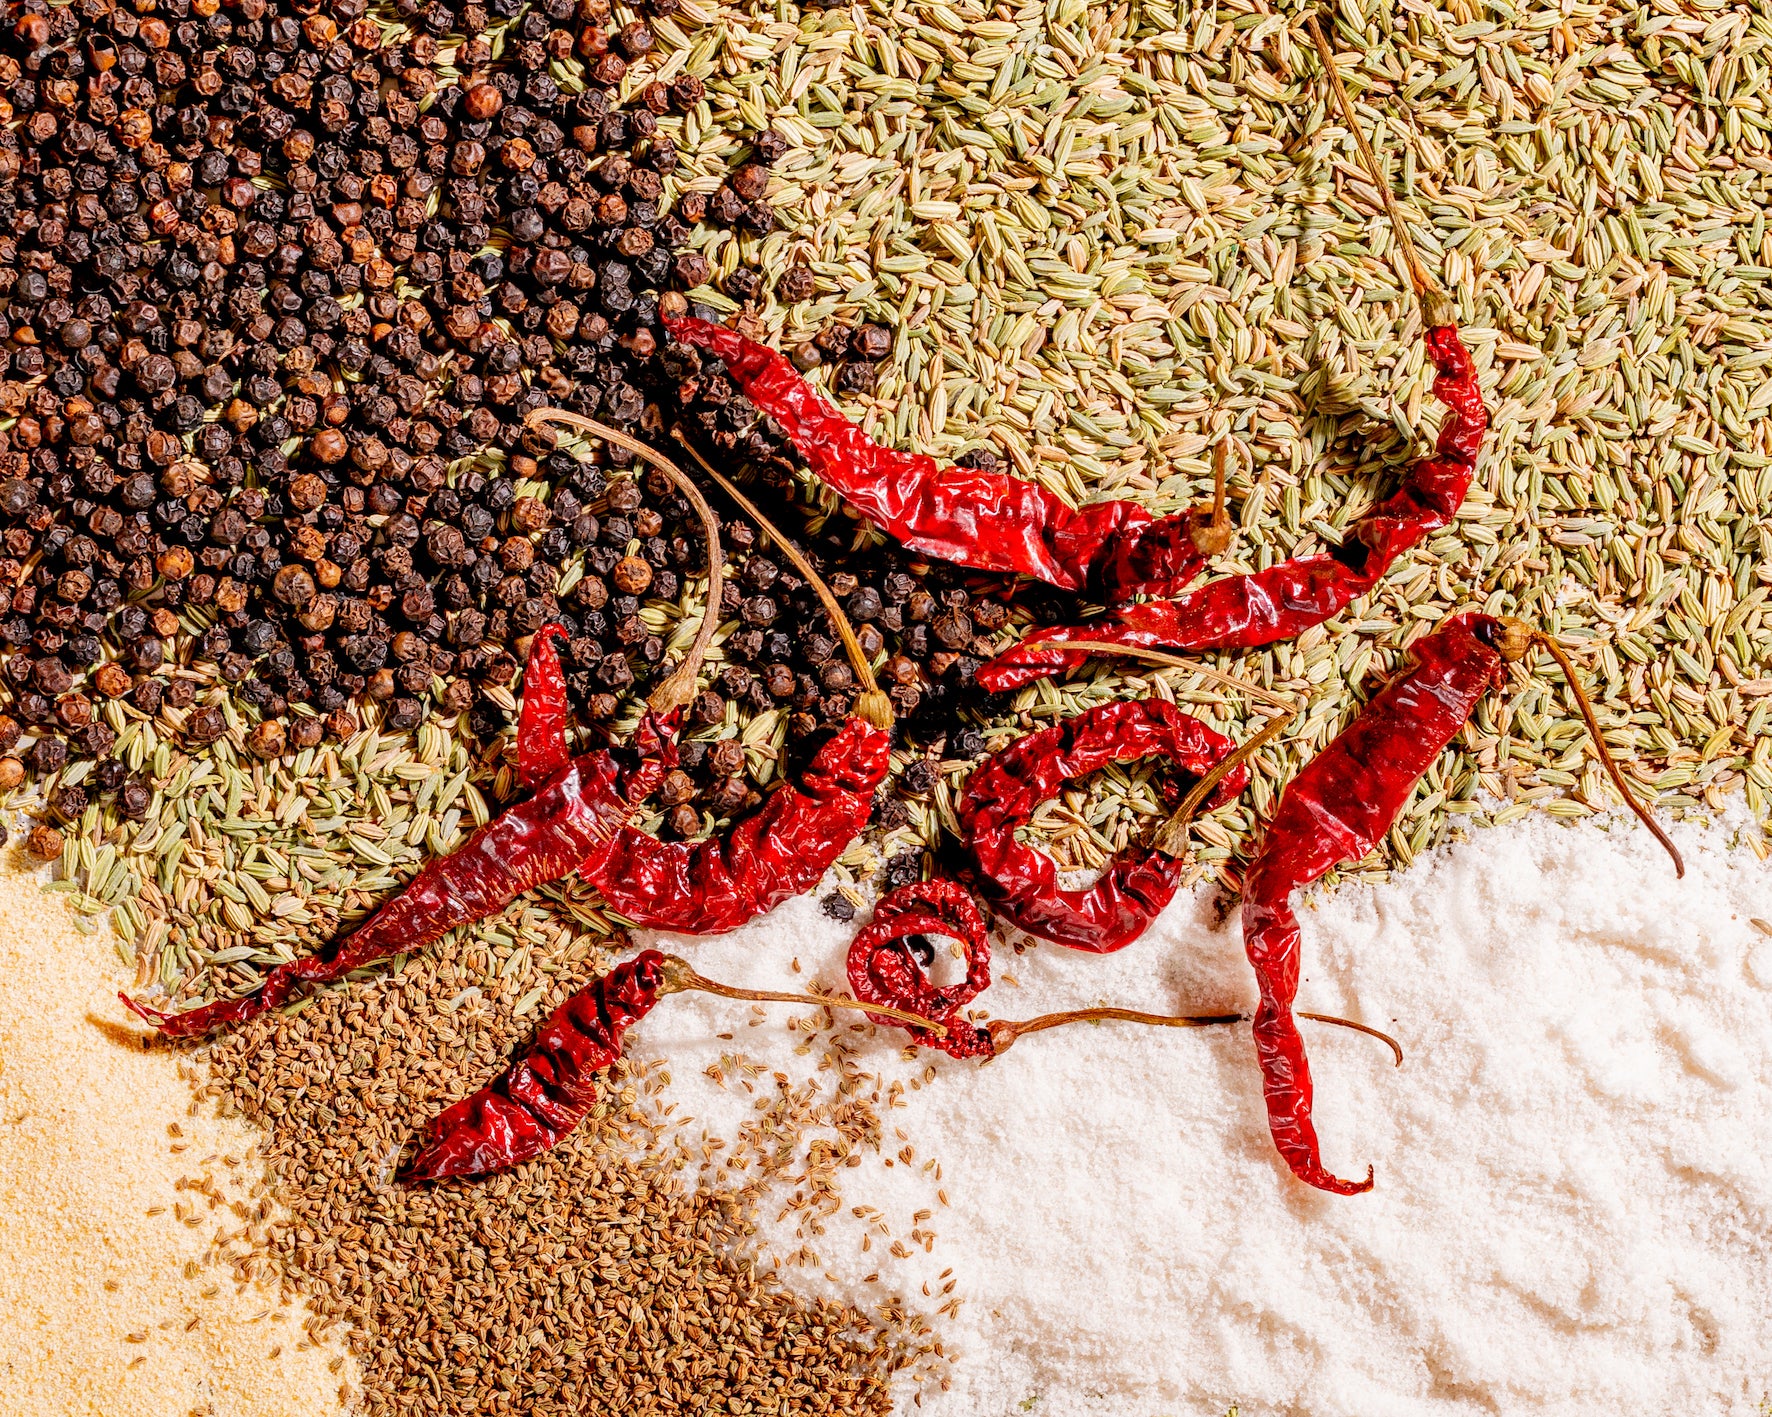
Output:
(397, 949), (665, 1185)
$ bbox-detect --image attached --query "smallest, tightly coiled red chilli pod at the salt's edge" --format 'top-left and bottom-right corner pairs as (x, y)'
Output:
(847, 880), (992, 1057)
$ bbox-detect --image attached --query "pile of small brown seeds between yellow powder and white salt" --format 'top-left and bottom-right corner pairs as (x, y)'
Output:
(202, 921), (923, 1417)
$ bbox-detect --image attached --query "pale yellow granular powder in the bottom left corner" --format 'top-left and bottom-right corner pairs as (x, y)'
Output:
(0, 850), (358, 1417)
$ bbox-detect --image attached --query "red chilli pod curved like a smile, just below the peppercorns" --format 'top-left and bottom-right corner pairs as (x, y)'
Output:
(583, 717), (890, 935)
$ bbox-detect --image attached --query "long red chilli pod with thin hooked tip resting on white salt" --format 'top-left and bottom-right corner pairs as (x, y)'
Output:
(1242, 615), (1504, 1196)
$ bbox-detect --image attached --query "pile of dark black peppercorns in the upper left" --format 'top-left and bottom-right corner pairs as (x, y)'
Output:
(0, 0), (1006, 829)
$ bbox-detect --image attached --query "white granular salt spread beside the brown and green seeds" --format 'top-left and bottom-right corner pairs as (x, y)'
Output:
(636, 820), (1772, 1417)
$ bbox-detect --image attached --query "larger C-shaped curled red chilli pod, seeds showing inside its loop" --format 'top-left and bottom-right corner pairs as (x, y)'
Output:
(957, 698), (1249, 955)
